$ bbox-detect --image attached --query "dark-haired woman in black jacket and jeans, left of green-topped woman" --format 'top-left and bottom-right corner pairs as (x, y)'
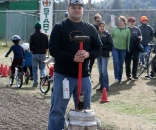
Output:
(96, 21), (113, 92)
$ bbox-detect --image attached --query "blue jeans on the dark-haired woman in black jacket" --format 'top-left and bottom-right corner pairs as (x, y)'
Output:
(97, 56), (109, 90)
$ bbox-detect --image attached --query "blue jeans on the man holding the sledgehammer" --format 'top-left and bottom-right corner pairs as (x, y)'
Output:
(48, 73), (92, 130)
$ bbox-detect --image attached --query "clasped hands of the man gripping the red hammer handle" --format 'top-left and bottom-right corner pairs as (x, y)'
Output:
(74, 50), (89, 62)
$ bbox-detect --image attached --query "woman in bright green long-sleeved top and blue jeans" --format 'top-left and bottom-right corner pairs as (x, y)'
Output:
(112, 16), (130, 82)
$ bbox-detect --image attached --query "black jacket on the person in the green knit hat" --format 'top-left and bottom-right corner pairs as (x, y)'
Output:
(30, 30), (48, 54)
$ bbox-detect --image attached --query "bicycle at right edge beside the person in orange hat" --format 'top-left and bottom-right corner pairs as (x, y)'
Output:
(138, 44), (156, 79)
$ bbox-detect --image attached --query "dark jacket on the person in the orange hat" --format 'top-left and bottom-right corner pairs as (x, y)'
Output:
(139, 24), (154, 45)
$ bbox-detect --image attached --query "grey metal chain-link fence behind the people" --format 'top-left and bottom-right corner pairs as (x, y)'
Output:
(0, 9), (156, 42)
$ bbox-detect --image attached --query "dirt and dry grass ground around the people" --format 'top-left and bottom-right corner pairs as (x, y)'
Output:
(0, 45), (156, 130)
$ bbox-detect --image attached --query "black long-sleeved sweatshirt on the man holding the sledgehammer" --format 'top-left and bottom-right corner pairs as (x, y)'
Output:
(49, 18), (101, 78)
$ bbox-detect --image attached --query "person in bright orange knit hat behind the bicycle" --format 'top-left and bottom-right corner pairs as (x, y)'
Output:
(138, 16), (154, 64)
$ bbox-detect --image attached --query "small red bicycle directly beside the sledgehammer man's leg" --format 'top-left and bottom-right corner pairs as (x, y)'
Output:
(40, 64), (54, 94)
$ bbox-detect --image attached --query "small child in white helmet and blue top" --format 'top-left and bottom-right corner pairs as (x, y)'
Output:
(22, 43), (33, 80)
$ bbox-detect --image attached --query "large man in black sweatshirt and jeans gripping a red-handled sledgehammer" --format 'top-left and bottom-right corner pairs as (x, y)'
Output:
(48, 0), (101, 130)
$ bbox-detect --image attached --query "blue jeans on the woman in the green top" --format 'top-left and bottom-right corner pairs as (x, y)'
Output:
(112, 48), (126, 81)
